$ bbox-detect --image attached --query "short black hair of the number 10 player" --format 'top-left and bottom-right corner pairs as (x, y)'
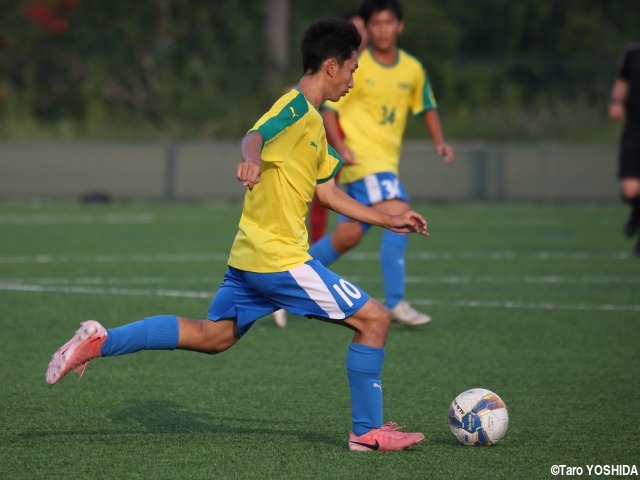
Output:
(300, 18), (362, 74)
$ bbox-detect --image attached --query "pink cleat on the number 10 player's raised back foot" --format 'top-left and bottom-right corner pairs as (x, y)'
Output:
(45, 320), (107, 385)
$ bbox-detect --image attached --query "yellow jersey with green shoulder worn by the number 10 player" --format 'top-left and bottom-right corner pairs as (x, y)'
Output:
(228, 89), (342, 273)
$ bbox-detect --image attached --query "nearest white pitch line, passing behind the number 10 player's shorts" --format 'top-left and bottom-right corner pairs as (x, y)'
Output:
(0, 282), (640, 312)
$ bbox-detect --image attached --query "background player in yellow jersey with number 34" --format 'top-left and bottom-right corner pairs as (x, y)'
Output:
(309, 0), (454, 326)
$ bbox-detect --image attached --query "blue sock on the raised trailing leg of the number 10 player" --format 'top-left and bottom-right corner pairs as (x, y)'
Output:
(101, 315), (178, 357)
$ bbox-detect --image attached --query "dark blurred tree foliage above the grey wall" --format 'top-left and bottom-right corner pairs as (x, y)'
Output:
(0, 0), (640, 139)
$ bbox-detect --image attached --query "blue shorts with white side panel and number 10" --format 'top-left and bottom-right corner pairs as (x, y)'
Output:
(207, 260), (369, 335)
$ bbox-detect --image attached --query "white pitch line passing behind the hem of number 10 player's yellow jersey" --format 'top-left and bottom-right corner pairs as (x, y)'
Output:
(0, 251), (632, 264)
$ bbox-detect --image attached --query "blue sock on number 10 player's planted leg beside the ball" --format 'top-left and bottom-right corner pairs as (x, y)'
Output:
(347, 343), (384, 435)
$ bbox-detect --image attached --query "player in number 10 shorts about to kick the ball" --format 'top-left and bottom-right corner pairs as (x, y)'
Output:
(45, 19), (428, 451)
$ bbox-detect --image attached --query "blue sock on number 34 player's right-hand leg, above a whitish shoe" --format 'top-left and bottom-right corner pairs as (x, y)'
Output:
(380, 230), (409, 308)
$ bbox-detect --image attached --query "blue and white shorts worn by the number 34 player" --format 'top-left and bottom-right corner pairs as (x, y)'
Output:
(338, 172), (409, 231)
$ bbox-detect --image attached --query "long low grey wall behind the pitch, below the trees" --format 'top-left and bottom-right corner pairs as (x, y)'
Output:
(0, 141), (618, 202)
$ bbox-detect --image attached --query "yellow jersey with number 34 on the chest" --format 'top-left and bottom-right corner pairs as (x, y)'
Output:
(323, 48), (437, 183)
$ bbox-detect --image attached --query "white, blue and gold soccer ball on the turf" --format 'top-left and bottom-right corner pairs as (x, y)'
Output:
(449, 388), (509, 446)
